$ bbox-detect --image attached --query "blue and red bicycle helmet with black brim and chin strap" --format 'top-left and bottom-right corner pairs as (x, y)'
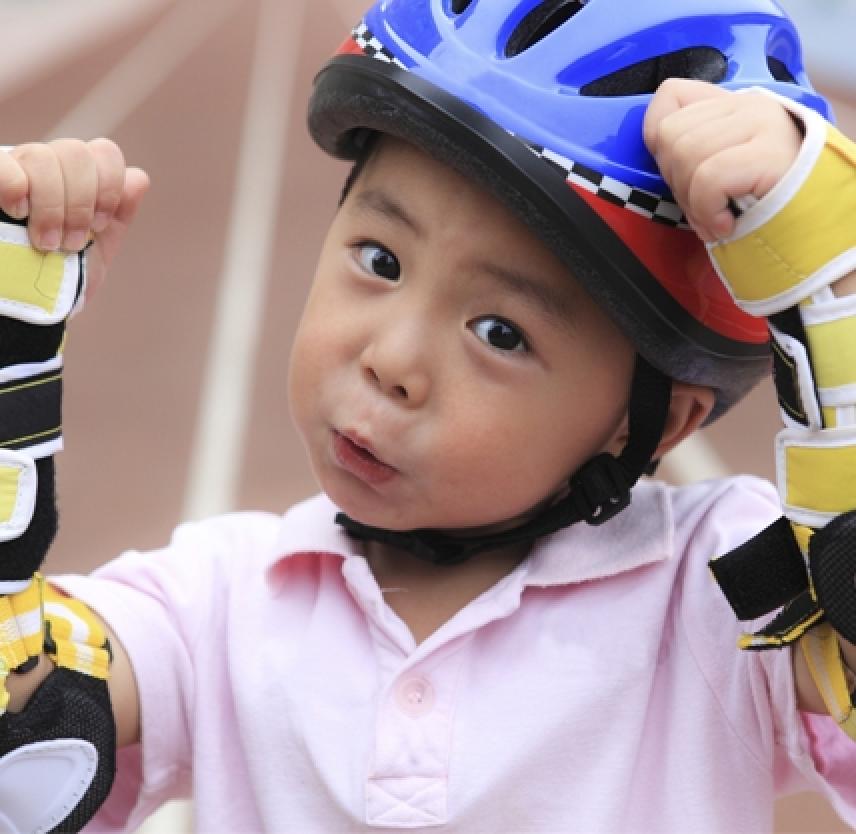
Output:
(309, 0), (830, 561)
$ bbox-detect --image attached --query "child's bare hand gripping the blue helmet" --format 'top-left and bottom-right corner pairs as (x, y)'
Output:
(644, 79), (802, 243)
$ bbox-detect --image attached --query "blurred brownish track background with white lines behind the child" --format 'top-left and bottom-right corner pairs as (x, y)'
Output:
(0, 0), (856, 834)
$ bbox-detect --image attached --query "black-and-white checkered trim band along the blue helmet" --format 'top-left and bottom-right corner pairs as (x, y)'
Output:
(351, 21), (689, 229)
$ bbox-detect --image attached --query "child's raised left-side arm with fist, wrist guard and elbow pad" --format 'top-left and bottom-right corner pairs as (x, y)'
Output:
(0, 140), (148, 831)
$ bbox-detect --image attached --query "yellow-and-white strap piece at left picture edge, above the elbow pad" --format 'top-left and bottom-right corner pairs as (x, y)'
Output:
(0, 574), (44, 715)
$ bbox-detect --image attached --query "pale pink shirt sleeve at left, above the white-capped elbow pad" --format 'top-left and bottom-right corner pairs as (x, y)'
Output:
(51, 514), (274, 834)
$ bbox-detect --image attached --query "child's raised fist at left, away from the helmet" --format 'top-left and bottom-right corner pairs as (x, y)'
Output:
(0, 139), (149, 296)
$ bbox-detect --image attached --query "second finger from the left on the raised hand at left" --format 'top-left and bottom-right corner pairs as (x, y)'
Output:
(11, 144), (65, 251)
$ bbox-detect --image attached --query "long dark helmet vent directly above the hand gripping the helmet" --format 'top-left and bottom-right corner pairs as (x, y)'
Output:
(580, 46), (728, 97)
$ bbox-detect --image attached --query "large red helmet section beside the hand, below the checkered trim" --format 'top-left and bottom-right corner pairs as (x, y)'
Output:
(571, 184), (769, 344)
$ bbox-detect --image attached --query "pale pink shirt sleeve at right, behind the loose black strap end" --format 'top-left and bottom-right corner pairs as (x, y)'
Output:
(674, 477), (856, 826)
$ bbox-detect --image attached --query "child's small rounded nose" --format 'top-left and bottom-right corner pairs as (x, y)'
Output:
(360, 326), (430, 407)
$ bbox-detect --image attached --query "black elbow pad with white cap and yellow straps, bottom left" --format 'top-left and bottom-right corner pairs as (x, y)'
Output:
(0, 575), (116, 834)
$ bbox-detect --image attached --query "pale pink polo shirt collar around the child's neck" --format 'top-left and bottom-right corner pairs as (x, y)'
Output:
(270, 482), (673, 587)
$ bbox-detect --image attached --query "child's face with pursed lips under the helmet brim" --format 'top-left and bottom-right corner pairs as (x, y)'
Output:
(290, 139), (634, 530)
